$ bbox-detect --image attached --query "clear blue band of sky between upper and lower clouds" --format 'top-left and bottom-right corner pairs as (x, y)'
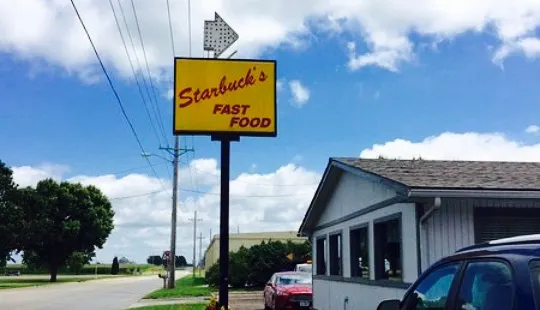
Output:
(0, 31), (540, 176)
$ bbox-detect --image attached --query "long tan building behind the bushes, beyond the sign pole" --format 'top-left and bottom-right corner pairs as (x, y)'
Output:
(204, 231), (307, 269)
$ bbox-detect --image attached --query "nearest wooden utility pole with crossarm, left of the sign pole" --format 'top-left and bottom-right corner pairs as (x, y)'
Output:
(156, 140), (193, 289)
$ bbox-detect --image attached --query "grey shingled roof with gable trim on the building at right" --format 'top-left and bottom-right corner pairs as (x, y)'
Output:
(299, 158), (540, 233)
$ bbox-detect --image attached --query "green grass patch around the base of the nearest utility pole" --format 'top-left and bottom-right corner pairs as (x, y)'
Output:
(145, 275), (216, 300)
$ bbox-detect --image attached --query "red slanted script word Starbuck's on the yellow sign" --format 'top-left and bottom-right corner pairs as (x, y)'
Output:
(178, 67), (268, 108)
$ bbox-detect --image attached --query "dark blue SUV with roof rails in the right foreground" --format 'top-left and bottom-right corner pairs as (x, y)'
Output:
(377, 235), (540, 310)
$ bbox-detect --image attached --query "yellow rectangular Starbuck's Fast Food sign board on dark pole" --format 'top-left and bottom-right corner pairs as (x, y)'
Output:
(174, 58), (277, 137)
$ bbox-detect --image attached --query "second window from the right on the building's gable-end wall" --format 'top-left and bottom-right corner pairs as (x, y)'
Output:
(349, 225), (369, 278)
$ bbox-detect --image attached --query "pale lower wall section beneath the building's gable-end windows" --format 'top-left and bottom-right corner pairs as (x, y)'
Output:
(313, 279), (405, 310)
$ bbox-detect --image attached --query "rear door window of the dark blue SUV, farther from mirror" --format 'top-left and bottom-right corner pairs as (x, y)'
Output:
(456, 261), (514, 310)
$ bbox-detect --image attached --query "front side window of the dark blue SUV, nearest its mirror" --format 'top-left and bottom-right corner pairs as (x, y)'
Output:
(402, 263), (460, 310)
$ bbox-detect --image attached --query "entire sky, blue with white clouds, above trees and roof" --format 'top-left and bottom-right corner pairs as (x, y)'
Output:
(0, 0), (540, 261)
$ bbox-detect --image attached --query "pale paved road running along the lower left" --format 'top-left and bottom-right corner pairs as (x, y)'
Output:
(0, 271), (188, 310)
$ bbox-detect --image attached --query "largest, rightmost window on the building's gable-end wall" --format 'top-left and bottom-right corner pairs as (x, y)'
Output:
(374, 214), (403, 281)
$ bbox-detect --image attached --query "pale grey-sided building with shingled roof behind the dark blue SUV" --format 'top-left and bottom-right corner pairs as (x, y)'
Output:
(299, 158), (540, 310)
